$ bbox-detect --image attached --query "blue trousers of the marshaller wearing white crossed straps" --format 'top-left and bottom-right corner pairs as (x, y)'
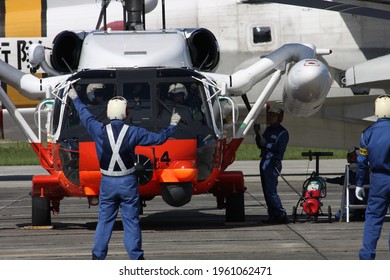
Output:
(92, 175), (144, 260)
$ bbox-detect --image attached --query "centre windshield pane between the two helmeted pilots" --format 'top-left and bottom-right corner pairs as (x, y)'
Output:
(123, 83), (151, 124)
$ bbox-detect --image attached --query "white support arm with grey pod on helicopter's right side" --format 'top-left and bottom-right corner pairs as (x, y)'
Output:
(204, 44), (333, 138)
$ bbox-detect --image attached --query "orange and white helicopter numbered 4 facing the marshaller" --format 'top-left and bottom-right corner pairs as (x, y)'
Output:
(0, 0), (332, 226)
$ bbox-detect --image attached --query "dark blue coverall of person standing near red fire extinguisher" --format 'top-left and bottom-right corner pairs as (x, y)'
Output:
(256, 123), (289, 220)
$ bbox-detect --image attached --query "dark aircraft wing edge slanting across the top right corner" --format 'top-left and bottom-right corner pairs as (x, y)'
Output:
(240, 0), (390, 19)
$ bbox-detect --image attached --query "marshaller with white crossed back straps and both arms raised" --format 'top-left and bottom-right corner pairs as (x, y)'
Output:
(68, 89), (180, 260)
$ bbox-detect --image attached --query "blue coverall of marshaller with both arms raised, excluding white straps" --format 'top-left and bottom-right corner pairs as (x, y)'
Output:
(73, 97), (176, 260)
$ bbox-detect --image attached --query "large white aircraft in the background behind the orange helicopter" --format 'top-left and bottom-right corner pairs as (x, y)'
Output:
(0, 0), (390, 149)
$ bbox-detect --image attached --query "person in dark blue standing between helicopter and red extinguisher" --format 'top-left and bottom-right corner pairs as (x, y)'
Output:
(255, 107), (289, 224)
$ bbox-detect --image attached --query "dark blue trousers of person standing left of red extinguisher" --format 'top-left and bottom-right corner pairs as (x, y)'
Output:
(260, 159), (286, 219)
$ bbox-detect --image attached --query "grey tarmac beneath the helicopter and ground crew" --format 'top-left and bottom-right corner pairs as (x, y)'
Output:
(0, 160), (390, 260)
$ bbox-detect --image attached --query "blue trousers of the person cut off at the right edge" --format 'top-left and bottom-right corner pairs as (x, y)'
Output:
(359, 173), (390, 260)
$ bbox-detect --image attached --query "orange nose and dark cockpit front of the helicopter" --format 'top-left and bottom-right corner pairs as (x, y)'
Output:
(32, 68), (243, 220)
